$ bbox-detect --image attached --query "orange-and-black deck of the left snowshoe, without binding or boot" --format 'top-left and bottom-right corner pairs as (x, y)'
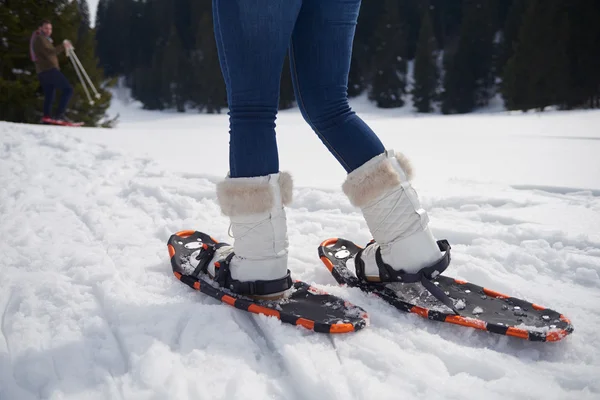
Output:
(168, 231), (368, 333)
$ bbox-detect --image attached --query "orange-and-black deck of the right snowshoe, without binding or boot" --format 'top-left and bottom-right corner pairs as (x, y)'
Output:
(318, 238), (573, 342)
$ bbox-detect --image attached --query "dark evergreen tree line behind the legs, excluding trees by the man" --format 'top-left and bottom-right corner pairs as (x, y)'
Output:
(96, 0), (600, 114)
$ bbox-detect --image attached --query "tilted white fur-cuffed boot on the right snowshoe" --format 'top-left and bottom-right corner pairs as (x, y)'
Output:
(342, 150), (444, 281)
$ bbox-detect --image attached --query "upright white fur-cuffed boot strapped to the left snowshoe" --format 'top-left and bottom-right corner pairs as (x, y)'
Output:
(207, 172), (293, 298)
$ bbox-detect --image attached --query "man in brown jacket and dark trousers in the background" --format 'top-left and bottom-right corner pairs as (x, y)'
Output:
(30, 20), (73, 124)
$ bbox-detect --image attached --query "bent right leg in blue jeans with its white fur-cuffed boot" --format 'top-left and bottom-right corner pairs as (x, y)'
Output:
(291, 0), (441, 280)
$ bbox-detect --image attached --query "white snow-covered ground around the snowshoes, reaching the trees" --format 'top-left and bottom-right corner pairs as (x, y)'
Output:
(0, 100), (600, 400)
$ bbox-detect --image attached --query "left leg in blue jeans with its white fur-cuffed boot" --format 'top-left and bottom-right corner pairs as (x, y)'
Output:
(207, 0), (302, 297)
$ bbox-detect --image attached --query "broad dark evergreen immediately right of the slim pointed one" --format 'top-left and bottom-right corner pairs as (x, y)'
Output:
(442, 0), (494, 114)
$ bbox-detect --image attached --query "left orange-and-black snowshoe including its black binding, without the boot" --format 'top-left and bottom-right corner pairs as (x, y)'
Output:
(167, 231), (368, 333)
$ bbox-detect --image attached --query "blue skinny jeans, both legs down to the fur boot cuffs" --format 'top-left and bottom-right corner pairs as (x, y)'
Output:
(213, 0), (385, 177)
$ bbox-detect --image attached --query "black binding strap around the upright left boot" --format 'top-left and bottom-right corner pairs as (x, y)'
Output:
(215, 253), (294, 296)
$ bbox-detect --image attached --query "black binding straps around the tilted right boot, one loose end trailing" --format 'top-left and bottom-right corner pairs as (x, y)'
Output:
(355, 240), (460, 315)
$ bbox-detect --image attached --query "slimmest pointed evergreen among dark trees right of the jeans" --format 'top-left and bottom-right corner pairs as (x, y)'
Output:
(412, 7), (439, 113)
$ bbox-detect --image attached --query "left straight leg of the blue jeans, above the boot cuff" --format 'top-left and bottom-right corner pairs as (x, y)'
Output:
(213, 0), (302, 177)
